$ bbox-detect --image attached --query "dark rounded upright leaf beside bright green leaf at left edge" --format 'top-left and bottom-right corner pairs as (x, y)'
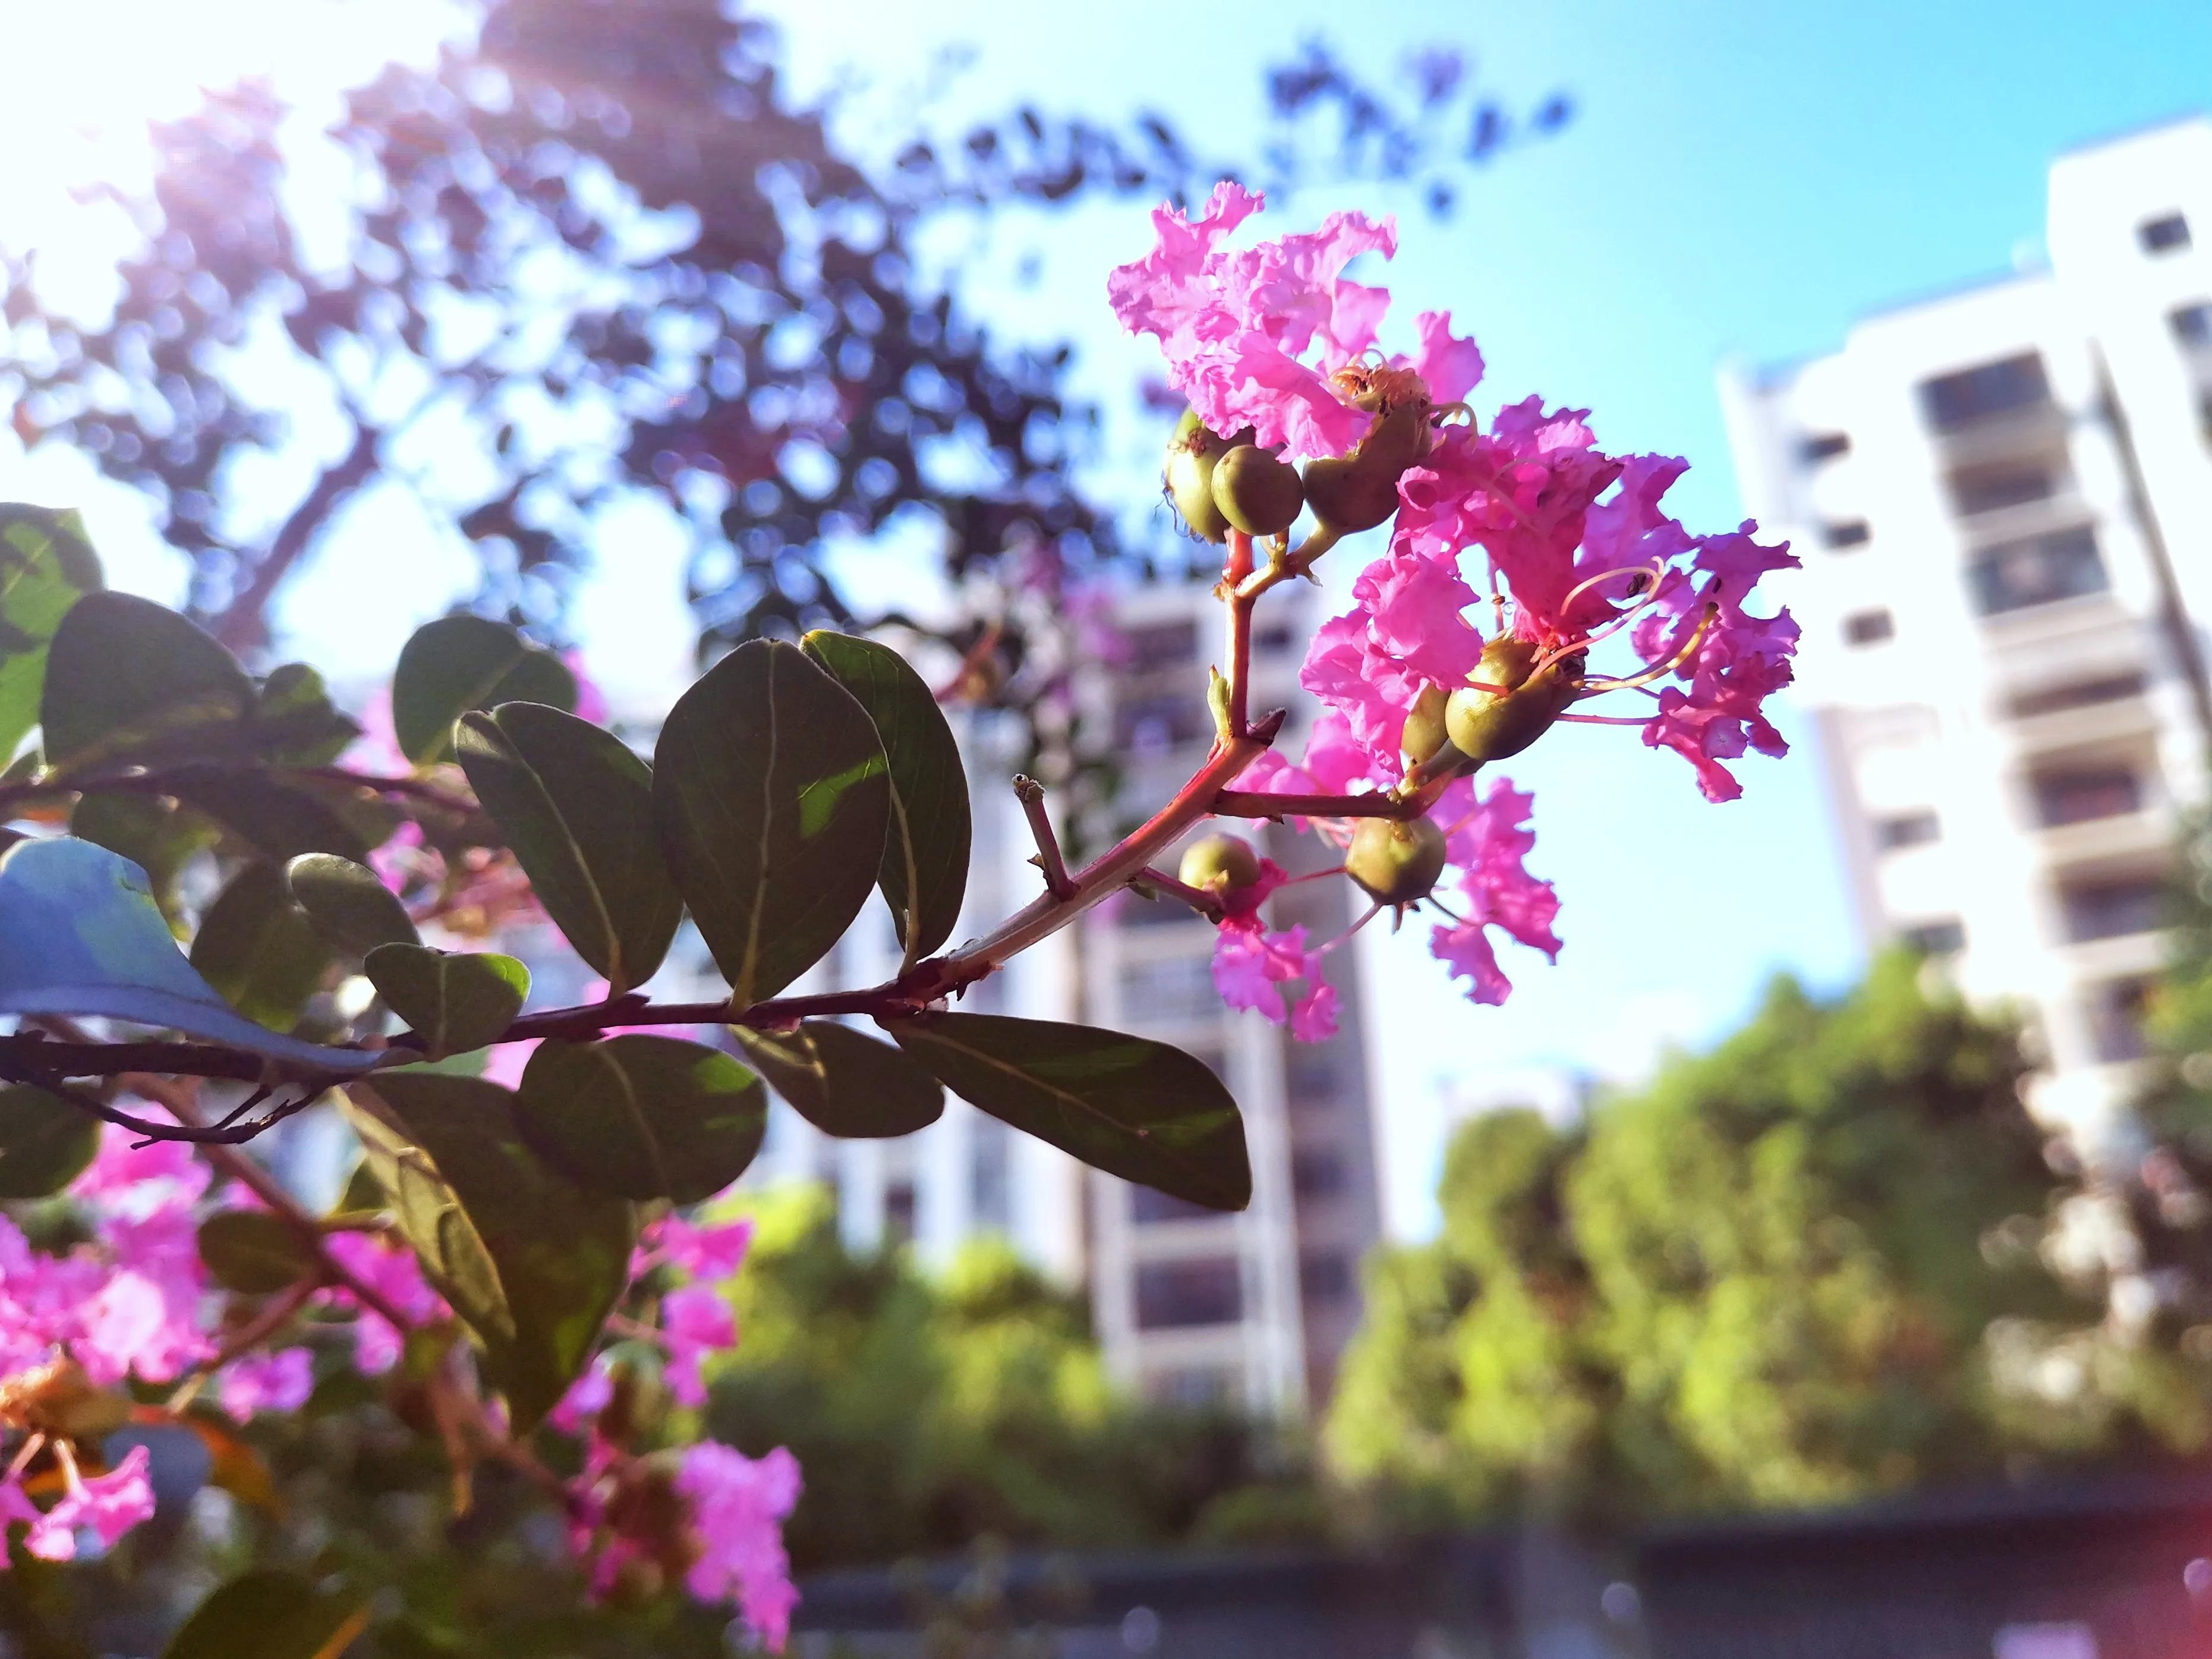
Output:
(37, 593), (254, 772)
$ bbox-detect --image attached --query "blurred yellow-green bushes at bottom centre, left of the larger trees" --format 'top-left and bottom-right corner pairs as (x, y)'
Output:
(708, 1188), (1321, 1573)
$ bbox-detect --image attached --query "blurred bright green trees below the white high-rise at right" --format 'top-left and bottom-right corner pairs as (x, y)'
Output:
(1327, 956), (2205, 1520)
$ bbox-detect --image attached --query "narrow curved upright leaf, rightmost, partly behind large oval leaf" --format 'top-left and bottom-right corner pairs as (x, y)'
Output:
(803, 631), (973, 967)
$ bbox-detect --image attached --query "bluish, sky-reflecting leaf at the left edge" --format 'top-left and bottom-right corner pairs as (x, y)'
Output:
(0, 836), (378, 1071)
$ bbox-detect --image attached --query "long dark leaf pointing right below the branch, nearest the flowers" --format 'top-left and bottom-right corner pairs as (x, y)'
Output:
(880, 1013), (1252, 1210)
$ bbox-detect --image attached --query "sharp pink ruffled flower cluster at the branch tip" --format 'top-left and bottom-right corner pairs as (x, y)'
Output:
(1108, 184), (1798, 1033)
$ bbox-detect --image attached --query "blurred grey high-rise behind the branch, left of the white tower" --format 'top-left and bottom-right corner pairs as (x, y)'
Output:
(1084, 586), (1381, 1416)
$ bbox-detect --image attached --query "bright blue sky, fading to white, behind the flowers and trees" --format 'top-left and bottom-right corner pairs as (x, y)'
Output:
(0, 0), (2212, 1230)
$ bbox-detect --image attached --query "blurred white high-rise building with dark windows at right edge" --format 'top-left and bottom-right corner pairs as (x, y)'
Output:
(1721, 117), (2212, 1139)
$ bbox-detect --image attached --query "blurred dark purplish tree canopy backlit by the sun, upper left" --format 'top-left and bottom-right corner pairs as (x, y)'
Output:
(0, 0), (1568, 677)
